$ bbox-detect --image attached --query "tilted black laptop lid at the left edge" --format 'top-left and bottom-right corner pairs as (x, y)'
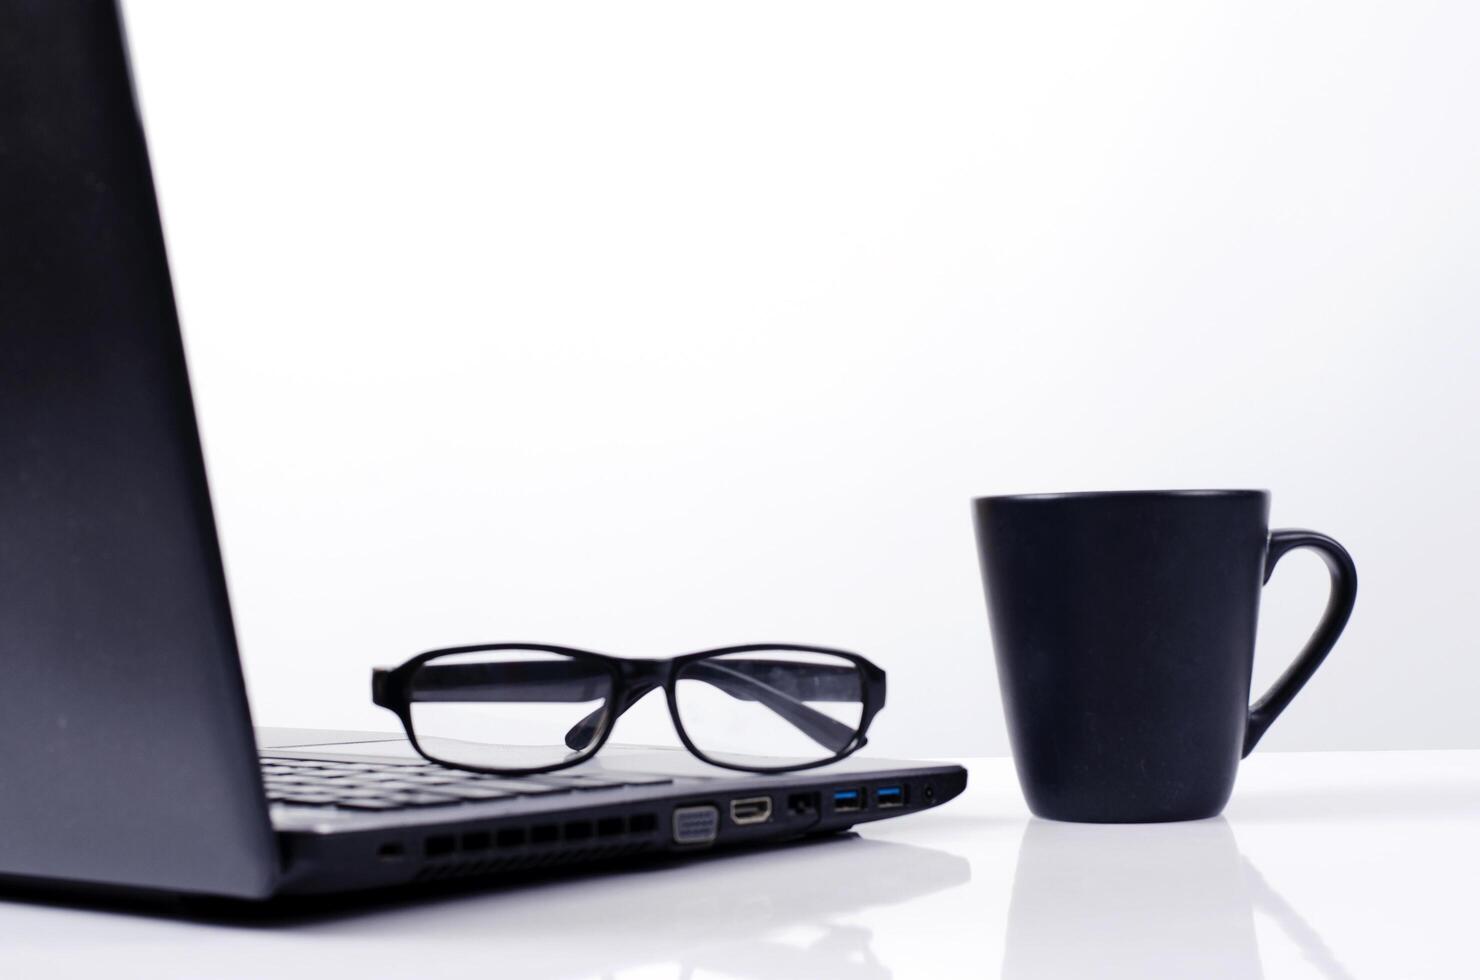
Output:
(0, 0), (278, 897)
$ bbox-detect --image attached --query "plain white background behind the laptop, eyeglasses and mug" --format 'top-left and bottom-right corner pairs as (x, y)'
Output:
(126, 0), (1480, 755)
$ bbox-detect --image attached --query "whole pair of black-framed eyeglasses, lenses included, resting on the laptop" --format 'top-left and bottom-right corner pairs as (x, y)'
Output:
(373, 642), (884, 776)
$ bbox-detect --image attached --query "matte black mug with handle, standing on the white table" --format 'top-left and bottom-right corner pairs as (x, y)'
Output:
(975, 490), (1357, 823)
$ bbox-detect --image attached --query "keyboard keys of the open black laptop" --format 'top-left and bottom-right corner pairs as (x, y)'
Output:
(262, 755), (673, 811)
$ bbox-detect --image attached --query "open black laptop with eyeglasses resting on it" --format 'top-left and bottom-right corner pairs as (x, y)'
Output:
(0, 0), (966, 900)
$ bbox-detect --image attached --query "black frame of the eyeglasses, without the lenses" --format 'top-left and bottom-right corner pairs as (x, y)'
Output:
(370, 642), (885, 776)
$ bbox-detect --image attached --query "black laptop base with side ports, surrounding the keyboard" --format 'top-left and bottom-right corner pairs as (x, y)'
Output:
(258, 730), (966, 894)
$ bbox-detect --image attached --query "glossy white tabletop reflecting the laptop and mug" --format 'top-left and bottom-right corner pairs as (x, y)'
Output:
(0, 752), (1480, 980)
